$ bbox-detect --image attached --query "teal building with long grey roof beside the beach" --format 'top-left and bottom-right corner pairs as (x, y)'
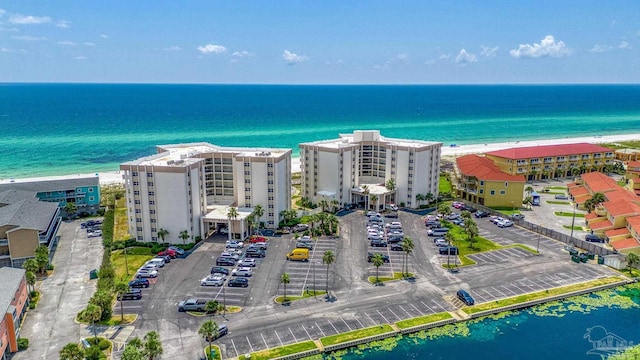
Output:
(0, 176), (100, 216)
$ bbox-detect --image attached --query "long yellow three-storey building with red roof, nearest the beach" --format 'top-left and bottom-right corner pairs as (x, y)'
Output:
(485, 143), (615, 181)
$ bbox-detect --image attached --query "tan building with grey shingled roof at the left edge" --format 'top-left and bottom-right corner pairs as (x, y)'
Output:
(0, 190), (62, 268)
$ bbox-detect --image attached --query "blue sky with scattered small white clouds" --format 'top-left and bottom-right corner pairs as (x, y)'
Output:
(0, 0), (640, 84)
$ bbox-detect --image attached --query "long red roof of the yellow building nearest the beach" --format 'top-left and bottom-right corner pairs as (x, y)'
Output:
(486, 143), (613, 160)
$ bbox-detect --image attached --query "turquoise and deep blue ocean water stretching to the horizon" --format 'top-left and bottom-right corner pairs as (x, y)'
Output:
(0, 84), (640, 179)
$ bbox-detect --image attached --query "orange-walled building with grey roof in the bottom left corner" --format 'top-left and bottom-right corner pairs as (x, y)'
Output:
(0, 267), (29, 360)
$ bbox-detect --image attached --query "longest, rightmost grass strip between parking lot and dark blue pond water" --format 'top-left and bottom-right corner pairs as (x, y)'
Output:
(462, 276), (628, 318)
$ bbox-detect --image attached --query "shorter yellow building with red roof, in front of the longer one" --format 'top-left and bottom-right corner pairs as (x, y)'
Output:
(454, 154), (525, 207)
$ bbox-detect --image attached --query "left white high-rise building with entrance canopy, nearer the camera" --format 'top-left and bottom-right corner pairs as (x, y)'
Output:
(120, 143), (291, 243)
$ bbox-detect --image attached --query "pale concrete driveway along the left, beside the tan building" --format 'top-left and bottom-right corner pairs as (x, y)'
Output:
(14, 220), (102, 360)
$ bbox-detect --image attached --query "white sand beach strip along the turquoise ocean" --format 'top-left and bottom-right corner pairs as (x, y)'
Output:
(0, 133), (640, 185)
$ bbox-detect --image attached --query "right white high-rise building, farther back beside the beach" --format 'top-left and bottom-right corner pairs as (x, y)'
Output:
(300, 130), (442, 210)
